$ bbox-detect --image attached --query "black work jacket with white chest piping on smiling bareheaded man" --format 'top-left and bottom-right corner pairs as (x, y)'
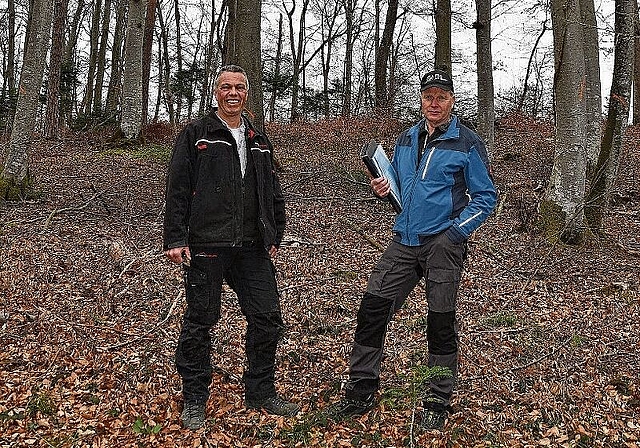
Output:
(163, 109), (285, 250)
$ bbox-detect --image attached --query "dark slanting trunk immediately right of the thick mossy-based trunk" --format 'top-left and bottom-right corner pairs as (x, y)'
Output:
(586, 0), (637, 234)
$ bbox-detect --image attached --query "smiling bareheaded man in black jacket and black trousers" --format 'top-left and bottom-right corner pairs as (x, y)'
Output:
(163, 65), (299, 429)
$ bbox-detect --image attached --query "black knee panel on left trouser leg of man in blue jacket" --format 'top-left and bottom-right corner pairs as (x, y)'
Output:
(355, 293), (394, 348)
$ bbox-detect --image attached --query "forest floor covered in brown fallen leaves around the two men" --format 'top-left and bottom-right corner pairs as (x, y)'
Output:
(0, 116), (640, 447)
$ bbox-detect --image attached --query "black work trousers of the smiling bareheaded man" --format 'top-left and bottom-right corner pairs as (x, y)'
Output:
(176, 245), (284, 401)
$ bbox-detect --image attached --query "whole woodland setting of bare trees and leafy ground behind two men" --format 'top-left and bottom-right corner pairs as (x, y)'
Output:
(0, 0), (640, 447)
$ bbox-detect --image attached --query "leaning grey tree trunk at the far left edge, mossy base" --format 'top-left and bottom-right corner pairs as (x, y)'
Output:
(0, 0), (53, 194)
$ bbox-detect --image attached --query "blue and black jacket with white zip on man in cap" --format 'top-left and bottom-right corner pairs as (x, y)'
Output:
(391, 115), (497, 246)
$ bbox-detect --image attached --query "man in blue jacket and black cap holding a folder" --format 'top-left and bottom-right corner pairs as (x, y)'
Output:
(329, 70), (496, 429)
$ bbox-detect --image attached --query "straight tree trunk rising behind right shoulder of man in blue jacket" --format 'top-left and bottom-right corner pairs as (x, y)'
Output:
(474, 0), (495, 156)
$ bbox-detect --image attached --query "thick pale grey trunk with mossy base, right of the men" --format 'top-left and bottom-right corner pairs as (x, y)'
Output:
(541, 0), (587, 244)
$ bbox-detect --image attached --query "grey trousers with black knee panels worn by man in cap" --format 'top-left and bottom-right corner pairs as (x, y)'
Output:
(345, 232), (466, 406)
